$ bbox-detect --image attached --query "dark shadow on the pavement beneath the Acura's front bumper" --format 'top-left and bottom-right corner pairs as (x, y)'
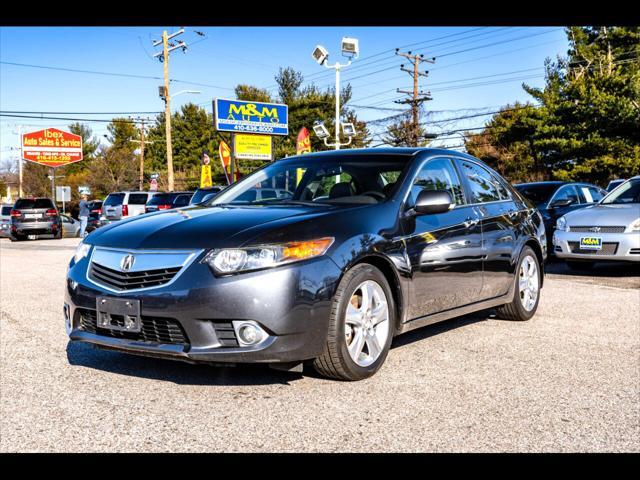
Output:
(67, 342), (303, 386)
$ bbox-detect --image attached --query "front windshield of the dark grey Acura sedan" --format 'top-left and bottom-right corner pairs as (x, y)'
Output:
(207, 154), (412, 205)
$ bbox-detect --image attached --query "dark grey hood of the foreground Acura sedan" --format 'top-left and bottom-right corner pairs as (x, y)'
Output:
(85, 205), (344, 249)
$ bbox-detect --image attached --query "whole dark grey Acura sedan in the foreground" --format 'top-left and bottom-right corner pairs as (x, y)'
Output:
(64, 148), (546, 380)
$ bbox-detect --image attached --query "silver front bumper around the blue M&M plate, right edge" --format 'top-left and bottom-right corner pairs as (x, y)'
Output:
(553, 230), (640, 262)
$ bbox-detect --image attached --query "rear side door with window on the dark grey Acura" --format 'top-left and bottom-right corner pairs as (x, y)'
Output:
(458, 159), (525, 300)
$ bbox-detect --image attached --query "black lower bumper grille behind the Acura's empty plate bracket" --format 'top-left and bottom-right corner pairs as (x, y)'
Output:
(76, 308), (189, 345)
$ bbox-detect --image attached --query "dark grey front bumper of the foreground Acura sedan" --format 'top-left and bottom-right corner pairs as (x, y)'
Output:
(64, 254), (341, 363)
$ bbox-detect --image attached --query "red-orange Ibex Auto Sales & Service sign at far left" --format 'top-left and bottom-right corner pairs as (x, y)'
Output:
(22, 128), (82, 168)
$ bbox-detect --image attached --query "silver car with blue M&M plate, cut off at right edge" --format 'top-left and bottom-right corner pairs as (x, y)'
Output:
(553, 176), (640, 270)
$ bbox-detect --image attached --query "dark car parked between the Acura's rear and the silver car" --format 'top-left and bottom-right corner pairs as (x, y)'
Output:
(514, 182), (607, 253)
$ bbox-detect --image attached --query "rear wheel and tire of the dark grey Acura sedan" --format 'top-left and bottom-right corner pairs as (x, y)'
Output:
(498, 247), (542, 321)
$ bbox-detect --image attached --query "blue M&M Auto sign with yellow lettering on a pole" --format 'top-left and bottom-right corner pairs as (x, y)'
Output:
(213, 98), (289, 135)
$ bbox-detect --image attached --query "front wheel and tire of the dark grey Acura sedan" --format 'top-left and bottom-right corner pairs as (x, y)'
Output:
(313, 263), (396, 381)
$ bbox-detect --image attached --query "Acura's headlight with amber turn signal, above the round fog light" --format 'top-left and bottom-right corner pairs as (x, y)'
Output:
(204, 237), (334, 275)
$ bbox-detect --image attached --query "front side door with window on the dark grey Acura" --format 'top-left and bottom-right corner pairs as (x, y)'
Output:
(402, 157), (482, 320)
